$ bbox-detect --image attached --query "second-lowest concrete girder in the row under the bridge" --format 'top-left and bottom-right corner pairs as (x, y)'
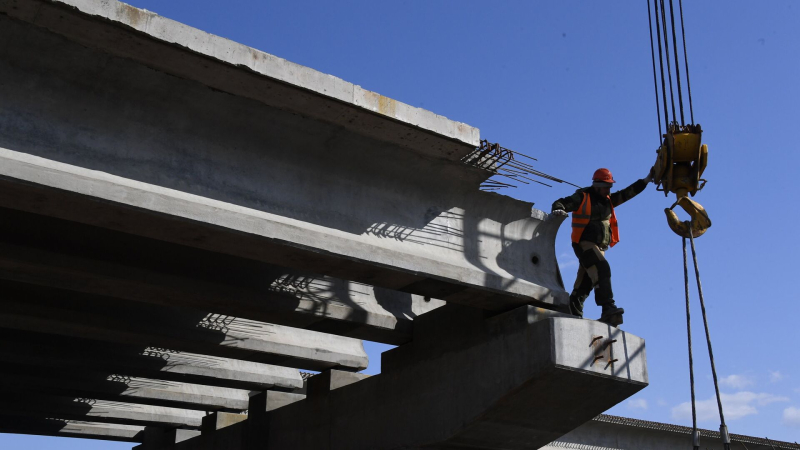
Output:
(0, 386), (205, 429)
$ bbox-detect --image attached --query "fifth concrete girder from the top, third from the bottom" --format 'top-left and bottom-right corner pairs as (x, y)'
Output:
(0, 364), (250, 412)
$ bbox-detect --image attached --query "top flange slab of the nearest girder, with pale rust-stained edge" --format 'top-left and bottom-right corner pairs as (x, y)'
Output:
(0, 0), (480, 156)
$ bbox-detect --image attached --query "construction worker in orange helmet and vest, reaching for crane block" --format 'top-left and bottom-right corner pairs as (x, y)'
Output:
(552, 169), (653, 326)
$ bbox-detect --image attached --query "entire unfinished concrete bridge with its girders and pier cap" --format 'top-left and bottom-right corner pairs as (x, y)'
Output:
(0, 0), (647, 450)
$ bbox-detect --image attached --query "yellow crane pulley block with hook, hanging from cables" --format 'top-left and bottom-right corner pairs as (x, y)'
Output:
(653, 124), (711, 238)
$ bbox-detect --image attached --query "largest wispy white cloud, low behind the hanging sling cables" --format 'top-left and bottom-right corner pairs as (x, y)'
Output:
(672, 391), (789, 420)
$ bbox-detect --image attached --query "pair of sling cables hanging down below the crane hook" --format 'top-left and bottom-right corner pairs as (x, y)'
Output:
(683, 229), (731, 450)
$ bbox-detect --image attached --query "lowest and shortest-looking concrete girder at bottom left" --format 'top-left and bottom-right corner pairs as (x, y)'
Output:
(0, 415), (144, 442)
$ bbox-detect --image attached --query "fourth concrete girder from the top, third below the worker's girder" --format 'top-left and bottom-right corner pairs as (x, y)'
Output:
(0, 329), (303, 390)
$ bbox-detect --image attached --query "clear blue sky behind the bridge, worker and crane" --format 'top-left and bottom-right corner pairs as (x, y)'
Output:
(0, 0), (800, 449)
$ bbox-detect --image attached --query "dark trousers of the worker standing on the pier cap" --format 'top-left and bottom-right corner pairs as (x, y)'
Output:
(569, 241), (614, 317)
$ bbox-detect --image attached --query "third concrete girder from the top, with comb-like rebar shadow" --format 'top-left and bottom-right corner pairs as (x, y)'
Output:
(0, 282), (368, 370)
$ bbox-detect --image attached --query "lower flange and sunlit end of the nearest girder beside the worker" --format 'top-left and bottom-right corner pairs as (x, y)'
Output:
(0, 148), (568, 311)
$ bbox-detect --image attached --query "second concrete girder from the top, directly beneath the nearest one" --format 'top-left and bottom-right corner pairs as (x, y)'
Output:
(0, 208), (444, 345)
